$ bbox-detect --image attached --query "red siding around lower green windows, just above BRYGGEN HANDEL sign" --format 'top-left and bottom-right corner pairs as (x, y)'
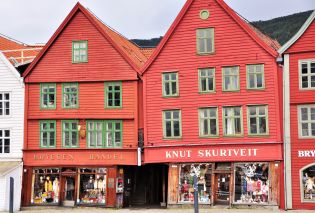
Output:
(27, 120), (137, 150)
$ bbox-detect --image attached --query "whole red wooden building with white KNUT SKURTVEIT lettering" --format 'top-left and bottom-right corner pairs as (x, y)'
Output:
(142, 0), (283, 206)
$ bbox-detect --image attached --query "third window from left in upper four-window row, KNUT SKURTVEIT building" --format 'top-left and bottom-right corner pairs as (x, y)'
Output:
(222, 67), (240, 91)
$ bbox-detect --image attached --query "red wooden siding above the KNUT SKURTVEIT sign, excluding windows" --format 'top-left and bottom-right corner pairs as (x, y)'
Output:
(144, 0), (281, 145)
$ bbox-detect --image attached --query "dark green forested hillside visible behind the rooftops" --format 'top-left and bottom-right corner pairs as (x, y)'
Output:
(131, 10), (312, 47)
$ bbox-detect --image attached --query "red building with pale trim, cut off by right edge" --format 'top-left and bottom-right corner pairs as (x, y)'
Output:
(279, 11), (315, 209)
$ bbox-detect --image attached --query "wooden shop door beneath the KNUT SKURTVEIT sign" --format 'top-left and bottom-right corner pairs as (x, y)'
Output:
(214, 173), (231, 205)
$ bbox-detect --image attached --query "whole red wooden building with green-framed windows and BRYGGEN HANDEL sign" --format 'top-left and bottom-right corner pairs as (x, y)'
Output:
(22, 3), (147, 206)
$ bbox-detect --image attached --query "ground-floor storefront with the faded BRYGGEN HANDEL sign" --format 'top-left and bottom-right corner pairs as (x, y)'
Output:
(22, 150), (137, 207)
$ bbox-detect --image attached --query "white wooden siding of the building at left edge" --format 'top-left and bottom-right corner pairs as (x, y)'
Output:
(0, 53), (24, 161)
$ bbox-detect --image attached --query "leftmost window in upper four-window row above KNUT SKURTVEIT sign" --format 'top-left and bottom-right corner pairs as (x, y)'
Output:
(162, 72), (179, 97)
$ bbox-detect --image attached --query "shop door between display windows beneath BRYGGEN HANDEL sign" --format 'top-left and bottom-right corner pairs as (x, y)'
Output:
(61, 176), (76, 206)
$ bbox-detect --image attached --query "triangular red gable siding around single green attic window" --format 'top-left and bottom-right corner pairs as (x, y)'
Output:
(25, 11), (137, 82)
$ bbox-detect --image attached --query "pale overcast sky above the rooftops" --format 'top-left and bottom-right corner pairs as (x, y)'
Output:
(0, 0), (315, 44)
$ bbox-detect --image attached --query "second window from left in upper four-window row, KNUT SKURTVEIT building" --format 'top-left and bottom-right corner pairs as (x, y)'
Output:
(198, 68), (215, 93)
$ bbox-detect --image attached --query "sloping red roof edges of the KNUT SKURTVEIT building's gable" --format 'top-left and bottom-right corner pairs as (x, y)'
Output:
(142, 0), (280, 74)
